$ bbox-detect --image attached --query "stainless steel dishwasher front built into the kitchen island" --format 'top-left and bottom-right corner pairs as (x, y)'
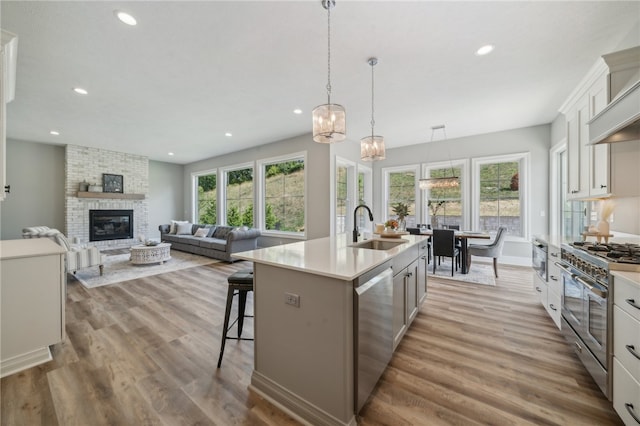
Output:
(354, 261), (393, 413)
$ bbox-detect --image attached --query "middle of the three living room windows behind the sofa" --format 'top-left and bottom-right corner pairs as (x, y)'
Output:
(224, 166), (253, 226)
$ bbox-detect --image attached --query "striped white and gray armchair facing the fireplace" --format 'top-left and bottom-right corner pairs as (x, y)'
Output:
(22, 226), (106, 275)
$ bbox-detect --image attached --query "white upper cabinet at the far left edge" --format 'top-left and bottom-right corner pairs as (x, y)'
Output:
(0, 30), (18, 201)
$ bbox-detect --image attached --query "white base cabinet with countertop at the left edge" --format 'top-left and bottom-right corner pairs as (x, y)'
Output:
(0, 238), (66, 377)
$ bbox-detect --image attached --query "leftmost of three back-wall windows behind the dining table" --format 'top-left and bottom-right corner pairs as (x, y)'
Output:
(383, 166), (418, 227)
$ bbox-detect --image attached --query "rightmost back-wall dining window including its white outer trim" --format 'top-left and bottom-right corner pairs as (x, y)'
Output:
(474, 154), (529, 237)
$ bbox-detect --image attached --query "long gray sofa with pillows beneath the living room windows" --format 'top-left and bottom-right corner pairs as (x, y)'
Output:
(158, 221), (260, 262)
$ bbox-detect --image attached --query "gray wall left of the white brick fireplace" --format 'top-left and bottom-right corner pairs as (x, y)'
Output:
(0, 140), (64, 240)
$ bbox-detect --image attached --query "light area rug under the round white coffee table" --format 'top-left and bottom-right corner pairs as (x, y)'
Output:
(75, 250), (219, 288)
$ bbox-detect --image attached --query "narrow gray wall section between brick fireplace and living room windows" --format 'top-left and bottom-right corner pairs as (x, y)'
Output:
(147, 161), (186, 238)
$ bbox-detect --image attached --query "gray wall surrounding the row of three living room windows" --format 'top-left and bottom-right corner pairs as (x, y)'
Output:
(181, 134), (331, 247)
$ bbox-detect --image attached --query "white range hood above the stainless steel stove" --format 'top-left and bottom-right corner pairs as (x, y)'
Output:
(588, 81), (640, 145)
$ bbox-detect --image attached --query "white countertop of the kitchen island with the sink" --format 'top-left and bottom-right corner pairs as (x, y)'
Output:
(232, 234), (428, 281)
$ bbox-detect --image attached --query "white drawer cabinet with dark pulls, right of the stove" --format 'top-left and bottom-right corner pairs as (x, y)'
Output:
(613, 274), (640, 425)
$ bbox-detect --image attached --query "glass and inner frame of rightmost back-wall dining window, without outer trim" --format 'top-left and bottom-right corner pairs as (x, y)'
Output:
(477, 160), (524, 236)
